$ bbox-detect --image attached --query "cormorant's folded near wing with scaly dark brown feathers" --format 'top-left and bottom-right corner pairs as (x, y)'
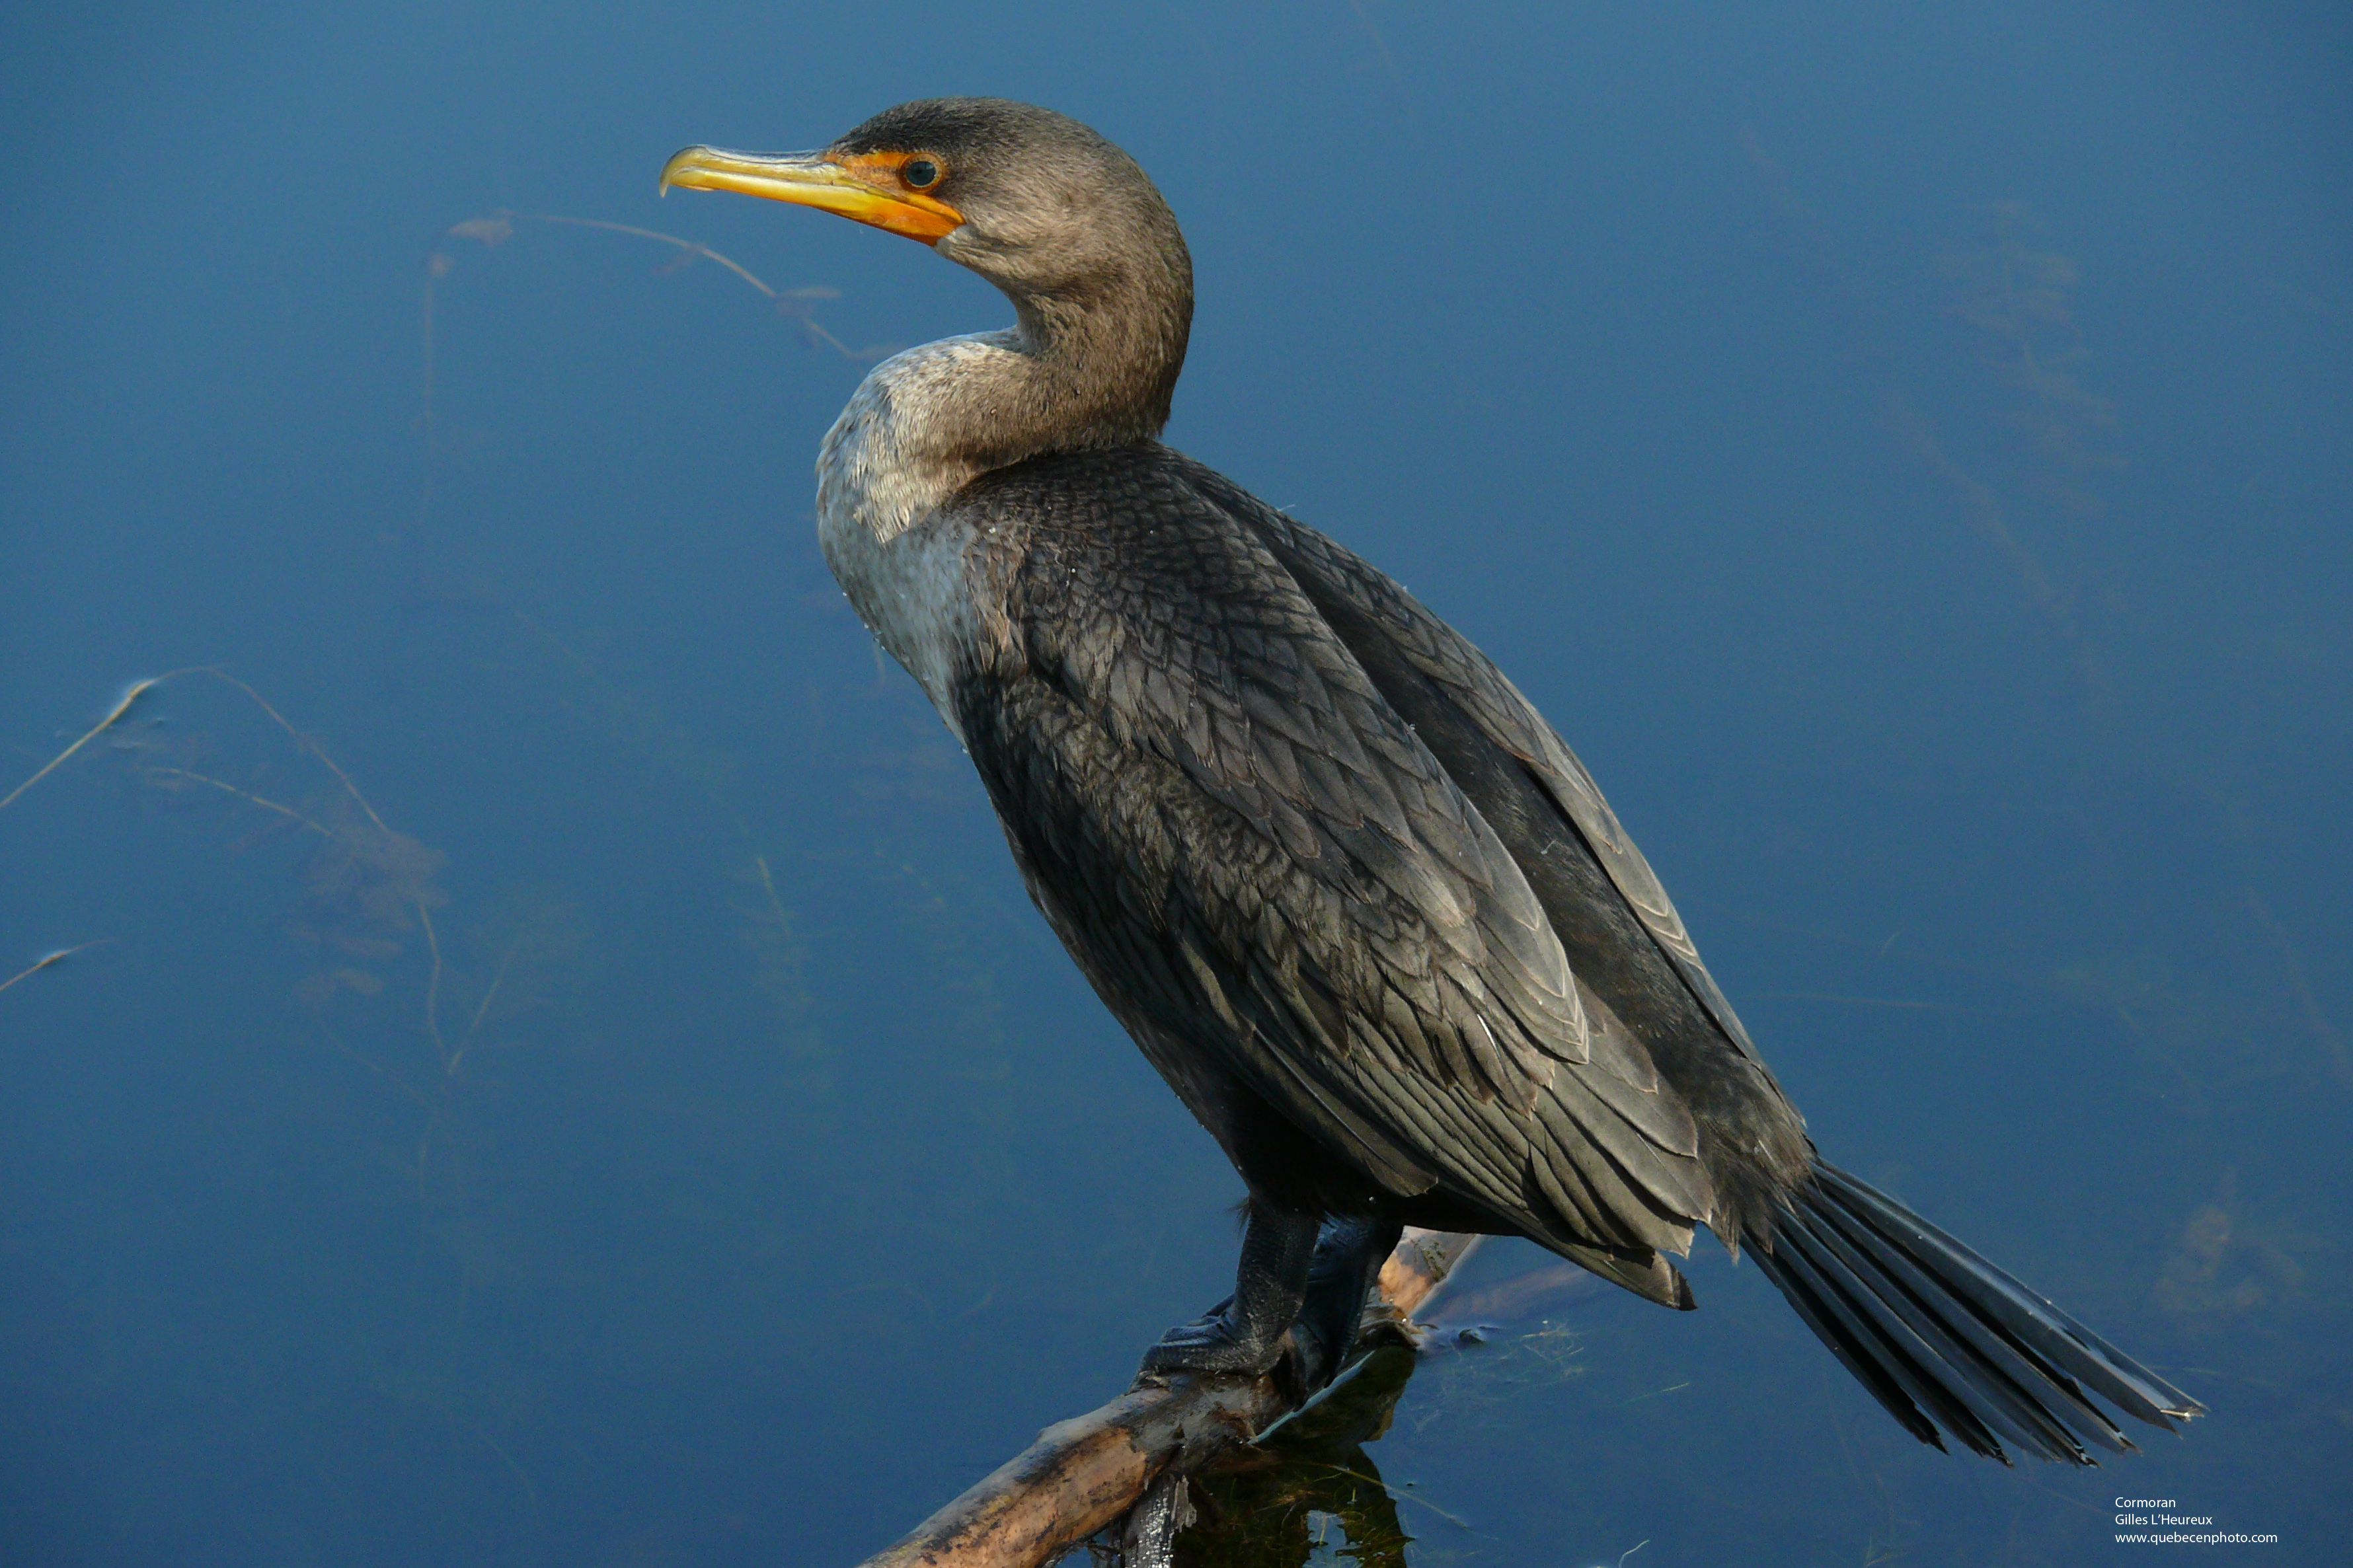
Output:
(960, 446), (1713, 1269)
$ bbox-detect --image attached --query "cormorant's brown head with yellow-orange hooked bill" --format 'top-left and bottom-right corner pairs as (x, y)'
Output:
(661, 98), (1193, 371)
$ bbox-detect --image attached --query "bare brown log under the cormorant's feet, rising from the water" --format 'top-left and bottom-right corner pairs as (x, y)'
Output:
(861, 1230), (1478, 1568)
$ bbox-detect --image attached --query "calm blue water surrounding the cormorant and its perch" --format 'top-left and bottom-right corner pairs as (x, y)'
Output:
(0, 0), (2353, 1568)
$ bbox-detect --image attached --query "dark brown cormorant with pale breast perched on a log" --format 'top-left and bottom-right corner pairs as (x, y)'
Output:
(661, 98), (2202, 1464)
